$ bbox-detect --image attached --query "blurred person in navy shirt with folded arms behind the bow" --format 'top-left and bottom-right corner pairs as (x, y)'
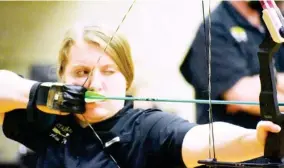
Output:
(180, 0), (284, 128)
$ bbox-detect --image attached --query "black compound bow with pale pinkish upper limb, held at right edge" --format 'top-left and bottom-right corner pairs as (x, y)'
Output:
(199, 0), (284, 168)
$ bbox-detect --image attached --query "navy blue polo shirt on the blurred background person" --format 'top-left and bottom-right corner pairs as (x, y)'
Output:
(180, 1), (284, 128)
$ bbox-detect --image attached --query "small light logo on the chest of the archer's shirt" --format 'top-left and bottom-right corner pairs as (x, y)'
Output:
(49, 123), (73, 144)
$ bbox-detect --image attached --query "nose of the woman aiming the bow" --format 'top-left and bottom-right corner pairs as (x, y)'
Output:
(87, 70), (103, 92)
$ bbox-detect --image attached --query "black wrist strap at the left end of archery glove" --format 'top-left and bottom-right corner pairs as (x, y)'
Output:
(27, 82), (41, 122)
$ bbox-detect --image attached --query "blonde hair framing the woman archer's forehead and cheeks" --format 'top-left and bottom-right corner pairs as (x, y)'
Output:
(57, 26), (134, 89)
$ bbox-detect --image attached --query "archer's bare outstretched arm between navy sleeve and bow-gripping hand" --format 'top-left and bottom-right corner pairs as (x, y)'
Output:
(182, 122), (264, 167)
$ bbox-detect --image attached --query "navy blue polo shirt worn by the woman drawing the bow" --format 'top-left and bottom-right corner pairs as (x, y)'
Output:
(3, 101), (195, 168)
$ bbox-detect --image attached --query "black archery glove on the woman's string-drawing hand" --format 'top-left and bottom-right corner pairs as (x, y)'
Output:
(27, 82), (87, 121)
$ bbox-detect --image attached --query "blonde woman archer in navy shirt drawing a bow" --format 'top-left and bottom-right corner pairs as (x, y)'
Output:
(0, 26), (280, 168)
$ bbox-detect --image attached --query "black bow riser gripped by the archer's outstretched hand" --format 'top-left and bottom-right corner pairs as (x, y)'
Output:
(258, 34), (284, 164)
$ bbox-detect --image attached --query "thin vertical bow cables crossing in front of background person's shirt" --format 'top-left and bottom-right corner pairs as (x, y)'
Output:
(202, 0), (216, 160)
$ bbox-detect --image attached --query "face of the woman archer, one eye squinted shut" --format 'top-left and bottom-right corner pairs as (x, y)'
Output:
(63, 42), (126, 123)
